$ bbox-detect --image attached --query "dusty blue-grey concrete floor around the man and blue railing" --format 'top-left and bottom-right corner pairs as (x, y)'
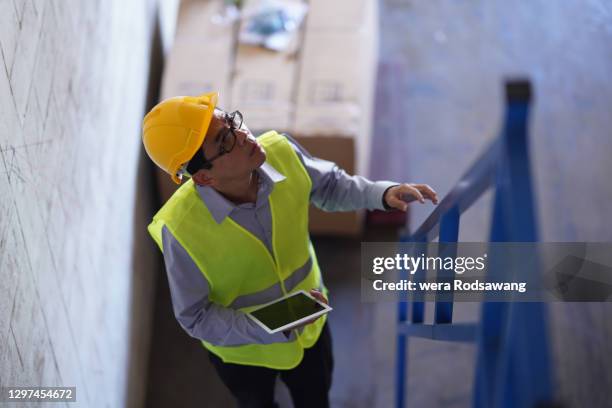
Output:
(147, 0), (612, 407)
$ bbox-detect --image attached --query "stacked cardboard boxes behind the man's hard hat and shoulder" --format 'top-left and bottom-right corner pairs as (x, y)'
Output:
(160, 0), (378, 235)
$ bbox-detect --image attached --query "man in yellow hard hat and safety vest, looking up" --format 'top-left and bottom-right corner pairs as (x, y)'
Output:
(143, 92), (437, 407)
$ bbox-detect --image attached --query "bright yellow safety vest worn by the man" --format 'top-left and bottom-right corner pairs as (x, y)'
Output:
(149, 131), (327, 369)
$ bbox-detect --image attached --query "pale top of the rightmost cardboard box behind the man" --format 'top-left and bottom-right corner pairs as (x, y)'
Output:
(293, 0), (378, 175)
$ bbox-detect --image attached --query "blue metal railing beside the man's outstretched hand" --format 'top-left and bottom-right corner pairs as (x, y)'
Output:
(395, 81), (552, 408)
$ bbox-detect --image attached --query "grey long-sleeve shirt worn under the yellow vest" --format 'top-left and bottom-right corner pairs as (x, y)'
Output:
(162, 135), (398, 346)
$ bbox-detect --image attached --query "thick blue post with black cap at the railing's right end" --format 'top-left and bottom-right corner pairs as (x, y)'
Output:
(473, 81), (552, 408)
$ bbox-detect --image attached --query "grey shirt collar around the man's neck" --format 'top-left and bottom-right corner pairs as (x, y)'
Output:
(195, 161), (286, 224)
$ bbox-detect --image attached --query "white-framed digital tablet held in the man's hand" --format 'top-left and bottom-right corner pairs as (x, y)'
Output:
(247, 290), (332, 334)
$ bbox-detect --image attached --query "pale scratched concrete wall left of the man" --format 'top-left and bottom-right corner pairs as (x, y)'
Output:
(0, 0), (164, 407)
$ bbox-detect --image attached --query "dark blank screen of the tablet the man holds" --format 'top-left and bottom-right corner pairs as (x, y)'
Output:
(251, 293), (324, 330)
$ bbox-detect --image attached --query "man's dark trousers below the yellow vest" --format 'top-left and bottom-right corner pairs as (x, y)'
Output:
(208, 323), (334, 408)
